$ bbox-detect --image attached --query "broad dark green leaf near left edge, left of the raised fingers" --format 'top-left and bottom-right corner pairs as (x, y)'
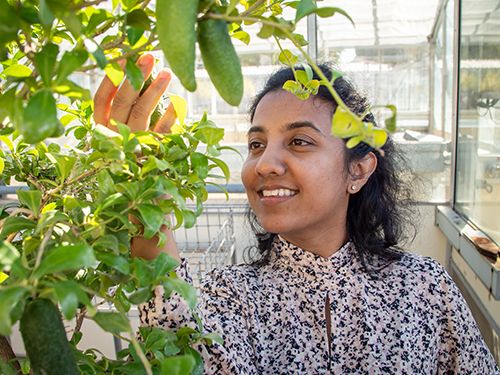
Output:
(17, 89), (62, 143)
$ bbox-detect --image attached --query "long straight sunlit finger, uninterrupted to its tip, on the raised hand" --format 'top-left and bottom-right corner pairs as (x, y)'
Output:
(127, 69), (172, 132)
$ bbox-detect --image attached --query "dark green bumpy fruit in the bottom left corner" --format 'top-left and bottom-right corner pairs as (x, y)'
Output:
(20, 298), (80, 375)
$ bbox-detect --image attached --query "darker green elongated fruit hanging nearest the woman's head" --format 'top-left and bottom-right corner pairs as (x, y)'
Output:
(198, 18), (243, 106)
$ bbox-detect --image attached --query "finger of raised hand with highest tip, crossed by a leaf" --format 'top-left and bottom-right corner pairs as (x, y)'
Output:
(109, 54), (155, 131)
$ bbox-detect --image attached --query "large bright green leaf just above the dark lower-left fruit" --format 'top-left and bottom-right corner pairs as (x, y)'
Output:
(33, 243), (96, 279)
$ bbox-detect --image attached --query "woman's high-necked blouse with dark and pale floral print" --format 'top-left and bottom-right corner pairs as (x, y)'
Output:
(140, 236), (500, 375)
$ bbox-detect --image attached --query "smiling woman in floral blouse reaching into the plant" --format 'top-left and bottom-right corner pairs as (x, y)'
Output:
(95, 56), (499, 374)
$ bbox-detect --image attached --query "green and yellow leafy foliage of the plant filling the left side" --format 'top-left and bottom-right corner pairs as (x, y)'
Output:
(0, 0), (396, 374)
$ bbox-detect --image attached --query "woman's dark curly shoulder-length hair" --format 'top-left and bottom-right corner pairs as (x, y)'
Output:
(247, 64), (417, 272)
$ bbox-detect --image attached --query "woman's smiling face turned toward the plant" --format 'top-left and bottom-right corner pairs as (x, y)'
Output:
(242, 90), (349, 251)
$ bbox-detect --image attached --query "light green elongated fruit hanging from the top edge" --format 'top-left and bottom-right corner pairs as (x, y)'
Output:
(156, 0), (199, 91)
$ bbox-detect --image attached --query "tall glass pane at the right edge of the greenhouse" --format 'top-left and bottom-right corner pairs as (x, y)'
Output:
(455, 0), (500, 243)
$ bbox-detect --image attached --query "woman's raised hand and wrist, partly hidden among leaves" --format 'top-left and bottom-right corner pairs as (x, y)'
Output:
(94, 54), (180, 261)
